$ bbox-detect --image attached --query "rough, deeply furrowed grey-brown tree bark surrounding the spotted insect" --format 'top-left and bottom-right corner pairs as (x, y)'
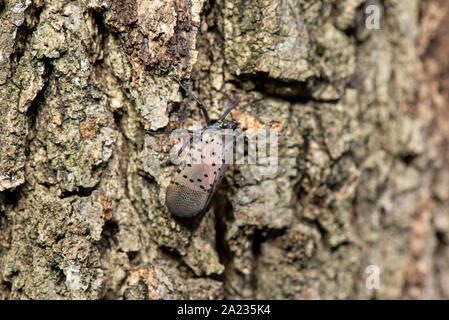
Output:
(0, 0), (449, 299)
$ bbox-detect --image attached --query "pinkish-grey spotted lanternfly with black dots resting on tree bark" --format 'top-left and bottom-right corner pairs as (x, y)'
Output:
(150, 80), (242, 217)
